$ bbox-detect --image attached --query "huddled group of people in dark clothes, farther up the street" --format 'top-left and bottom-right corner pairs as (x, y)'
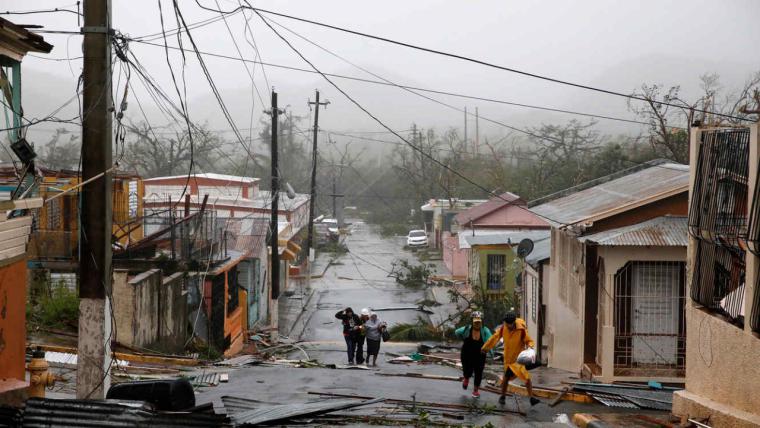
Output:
(335, 308), (388, 366)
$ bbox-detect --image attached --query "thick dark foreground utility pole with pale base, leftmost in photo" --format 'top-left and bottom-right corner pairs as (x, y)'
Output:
(77, 0), (115, 399)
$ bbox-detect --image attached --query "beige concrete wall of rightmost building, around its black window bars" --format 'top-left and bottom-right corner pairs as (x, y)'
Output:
(673, 124), (760, 427)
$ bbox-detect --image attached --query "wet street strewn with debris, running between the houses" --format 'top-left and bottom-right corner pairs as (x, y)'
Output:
(197, 221), (574, 426)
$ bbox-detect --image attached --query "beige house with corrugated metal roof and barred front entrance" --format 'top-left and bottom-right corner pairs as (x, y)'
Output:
(531, 161), (689, 381)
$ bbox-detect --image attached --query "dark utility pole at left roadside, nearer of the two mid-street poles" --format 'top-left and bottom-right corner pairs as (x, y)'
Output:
(269, 90), (280, 339)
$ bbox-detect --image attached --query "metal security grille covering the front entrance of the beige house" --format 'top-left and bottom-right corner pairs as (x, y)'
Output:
(613, 261), (686, 376)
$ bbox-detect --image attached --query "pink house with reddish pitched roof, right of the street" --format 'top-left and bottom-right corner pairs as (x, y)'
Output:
(442, 192), (550, 279)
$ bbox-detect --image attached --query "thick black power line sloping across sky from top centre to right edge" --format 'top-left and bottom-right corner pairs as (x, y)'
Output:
(252, 8), (751, 121)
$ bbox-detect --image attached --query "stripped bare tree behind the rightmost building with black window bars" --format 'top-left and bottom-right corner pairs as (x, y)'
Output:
(628, 72), (760, 164)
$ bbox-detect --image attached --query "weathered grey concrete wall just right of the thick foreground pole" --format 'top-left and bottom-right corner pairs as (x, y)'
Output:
(113, 269), (188, 352)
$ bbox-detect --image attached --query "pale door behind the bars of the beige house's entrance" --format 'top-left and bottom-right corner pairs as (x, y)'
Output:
(631, 262), (681, 364)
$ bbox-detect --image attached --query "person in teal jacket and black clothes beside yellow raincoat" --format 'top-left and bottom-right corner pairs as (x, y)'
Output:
(454, 311), (491, 398)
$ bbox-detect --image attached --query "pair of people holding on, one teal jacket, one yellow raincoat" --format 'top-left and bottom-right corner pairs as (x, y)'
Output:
(454, 312), (540, 405)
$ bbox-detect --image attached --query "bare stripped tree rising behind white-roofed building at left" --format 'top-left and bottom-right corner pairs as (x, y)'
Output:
(123, 123), (224, 178)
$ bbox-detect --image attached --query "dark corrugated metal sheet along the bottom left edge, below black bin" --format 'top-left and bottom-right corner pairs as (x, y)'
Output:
(21, 398), (231, 428)
